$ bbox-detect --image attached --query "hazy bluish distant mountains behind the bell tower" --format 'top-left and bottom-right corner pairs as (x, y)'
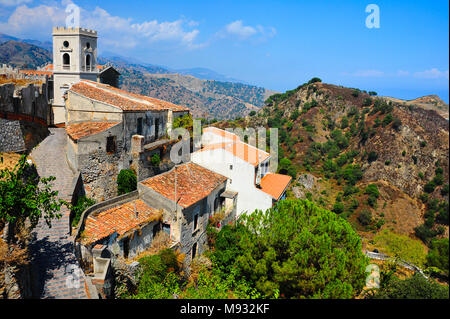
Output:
(0, 34), (276, 119)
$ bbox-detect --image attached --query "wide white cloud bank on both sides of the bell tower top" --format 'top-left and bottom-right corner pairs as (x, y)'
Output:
(0, 0), (202, 49)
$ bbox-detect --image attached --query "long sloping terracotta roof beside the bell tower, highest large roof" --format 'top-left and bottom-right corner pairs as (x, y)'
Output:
(70, 80), (189, 111)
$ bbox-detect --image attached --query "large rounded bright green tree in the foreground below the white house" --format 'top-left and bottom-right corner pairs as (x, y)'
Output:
(212, 200), (367, 298)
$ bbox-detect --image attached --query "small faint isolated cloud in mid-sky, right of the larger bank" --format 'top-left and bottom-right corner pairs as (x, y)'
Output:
(218, 20), (276, 40)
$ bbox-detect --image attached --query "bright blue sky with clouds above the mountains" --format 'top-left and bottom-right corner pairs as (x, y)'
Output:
(0, 0), (449, 103)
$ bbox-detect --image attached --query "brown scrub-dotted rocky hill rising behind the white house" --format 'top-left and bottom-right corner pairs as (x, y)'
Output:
(214, 78), (449, 278)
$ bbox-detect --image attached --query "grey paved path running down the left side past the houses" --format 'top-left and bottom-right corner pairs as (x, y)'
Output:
(31, 128), (88, 299)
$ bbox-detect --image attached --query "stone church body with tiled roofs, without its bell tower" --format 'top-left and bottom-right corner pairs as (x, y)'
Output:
(65, 80), (189, 200)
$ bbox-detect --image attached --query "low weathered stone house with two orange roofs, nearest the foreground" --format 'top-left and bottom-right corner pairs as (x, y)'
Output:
(76, 163), (237, 265)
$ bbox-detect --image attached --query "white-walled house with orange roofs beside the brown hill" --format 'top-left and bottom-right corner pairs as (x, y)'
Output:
(191, 127), (292, 216)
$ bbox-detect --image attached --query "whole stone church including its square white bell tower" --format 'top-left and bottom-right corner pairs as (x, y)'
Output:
(47, 27), (189, 201)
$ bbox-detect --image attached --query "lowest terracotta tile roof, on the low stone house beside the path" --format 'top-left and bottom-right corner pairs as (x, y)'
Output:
(83, 199), (162, 244)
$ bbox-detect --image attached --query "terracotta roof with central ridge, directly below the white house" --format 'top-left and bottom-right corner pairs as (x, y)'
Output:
(142, 163), (227, 208)
